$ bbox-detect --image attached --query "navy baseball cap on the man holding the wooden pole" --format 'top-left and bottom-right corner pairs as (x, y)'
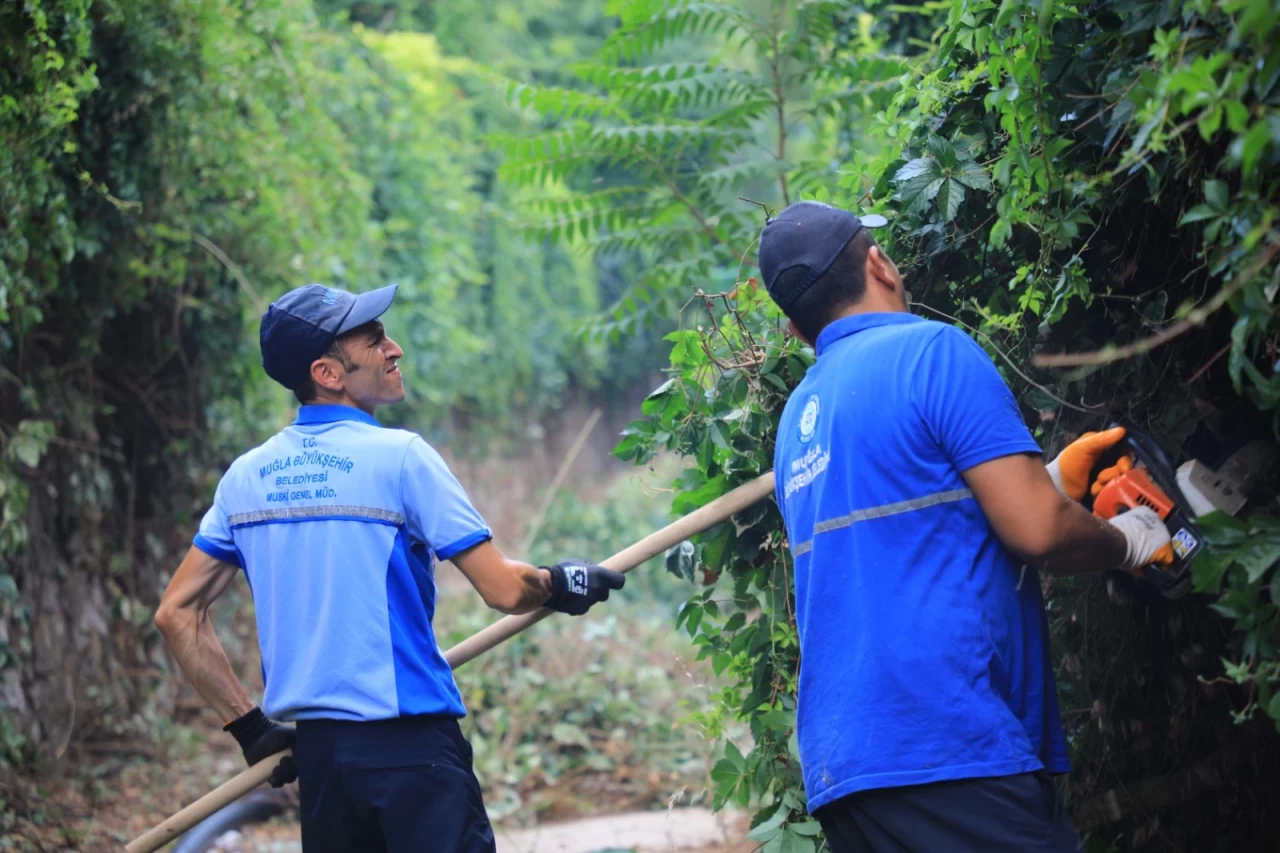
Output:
(259, 284), (397, 391)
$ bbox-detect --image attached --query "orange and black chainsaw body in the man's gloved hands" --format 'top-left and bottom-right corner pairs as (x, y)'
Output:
(1089, 424), (1203, 599)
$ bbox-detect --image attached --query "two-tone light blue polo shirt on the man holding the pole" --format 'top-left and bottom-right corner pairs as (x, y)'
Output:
(195, 405), (490, 720)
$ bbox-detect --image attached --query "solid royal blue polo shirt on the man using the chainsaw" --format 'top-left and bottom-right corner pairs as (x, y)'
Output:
(774, 314), (1068, 809)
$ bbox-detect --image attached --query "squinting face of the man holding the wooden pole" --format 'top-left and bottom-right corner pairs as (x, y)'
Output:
(311, 320), (404, 415)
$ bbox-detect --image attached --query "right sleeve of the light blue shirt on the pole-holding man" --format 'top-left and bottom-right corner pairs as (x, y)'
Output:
(401, 437), (493, 560)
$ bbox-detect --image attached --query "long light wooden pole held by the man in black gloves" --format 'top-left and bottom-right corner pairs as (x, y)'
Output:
(124, 471), (773, 853)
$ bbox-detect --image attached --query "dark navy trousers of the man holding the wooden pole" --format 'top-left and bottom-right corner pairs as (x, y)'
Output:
(294, 717), (495, 853)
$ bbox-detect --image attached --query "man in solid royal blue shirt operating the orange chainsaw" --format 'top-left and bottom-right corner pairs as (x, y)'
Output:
(759, 201), (1172, 853)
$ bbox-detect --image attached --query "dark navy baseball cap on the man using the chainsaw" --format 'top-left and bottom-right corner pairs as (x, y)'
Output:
(759, 201), (888, 313)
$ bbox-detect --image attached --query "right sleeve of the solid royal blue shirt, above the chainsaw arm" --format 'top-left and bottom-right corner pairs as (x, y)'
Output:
(914, 325), (1041, 473)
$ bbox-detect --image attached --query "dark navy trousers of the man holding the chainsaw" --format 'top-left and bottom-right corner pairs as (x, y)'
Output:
(814, 771), (1082, 853)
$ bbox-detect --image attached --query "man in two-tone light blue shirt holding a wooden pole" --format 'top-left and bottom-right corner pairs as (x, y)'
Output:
(155, 284), (625, 853)
